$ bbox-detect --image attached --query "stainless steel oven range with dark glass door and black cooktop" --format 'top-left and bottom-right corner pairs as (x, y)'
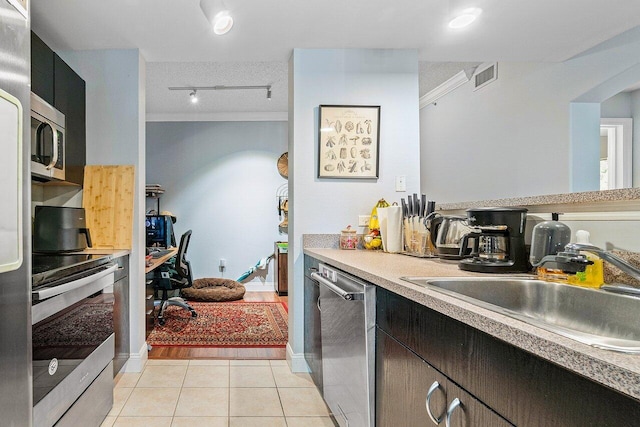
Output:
(32, 254), (117, 427)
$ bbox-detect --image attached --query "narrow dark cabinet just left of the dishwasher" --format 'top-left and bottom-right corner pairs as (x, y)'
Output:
(304, 256), (322, 393)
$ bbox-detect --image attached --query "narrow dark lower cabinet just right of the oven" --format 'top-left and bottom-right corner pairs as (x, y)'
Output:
(113, 255), (130, 377)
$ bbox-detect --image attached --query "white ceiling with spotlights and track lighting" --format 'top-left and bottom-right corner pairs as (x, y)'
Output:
(31, 0), (640, 114)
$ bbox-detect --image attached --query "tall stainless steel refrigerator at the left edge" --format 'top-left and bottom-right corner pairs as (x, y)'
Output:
(0, 0), (32, 427)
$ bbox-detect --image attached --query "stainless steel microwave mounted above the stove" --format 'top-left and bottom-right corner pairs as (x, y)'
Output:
(31, 93), (65, 181)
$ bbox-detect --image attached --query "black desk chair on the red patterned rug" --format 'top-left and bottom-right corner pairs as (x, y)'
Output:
(153, 230), (198, 325)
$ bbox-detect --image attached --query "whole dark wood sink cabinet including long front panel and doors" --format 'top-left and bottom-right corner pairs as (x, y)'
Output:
(376, 288), (640, 427)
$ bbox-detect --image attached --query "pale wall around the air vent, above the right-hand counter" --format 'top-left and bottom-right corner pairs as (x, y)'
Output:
(420, 29), (640, 202)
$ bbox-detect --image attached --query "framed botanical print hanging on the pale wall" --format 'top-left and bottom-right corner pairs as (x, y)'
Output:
(318, 105), (380, 179)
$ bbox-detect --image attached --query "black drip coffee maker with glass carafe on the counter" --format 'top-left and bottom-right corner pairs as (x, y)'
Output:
(458, 208), (529, 273)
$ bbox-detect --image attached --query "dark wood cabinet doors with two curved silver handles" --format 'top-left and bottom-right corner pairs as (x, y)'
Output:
(376, 329), (512, 427)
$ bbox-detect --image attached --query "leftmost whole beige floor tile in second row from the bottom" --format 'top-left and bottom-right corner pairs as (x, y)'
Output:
(120, 387), (180, 416)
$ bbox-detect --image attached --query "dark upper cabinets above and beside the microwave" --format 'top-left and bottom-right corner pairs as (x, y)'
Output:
(31, 31), (87, 185)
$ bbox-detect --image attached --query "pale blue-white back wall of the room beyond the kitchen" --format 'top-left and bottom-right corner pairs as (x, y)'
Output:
(146, 121), (287, 290)
